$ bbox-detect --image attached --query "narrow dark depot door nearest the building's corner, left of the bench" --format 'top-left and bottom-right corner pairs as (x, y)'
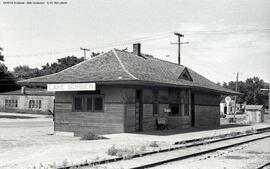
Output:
(135, 90), (143, 131)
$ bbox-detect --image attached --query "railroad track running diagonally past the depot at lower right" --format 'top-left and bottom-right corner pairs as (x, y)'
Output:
(58, 127), (270, 169)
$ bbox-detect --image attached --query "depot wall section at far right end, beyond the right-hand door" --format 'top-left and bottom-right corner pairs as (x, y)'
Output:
(194, 93), (220, 127)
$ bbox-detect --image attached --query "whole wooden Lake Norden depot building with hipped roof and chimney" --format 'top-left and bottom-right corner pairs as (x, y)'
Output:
(19, 44), (238, 135)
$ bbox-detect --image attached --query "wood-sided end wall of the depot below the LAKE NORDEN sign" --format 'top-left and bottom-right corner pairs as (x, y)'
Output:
(54, 88), (128, 135)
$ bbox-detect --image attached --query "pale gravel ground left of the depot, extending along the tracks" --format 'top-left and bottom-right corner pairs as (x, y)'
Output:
(0, 112), (269, 169)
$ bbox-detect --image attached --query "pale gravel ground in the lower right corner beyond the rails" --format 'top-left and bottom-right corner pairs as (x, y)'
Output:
(154, 138), (270, 169)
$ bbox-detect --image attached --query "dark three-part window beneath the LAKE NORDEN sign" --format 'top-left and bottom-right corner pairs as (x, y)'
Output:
(73, 95), (104, 112)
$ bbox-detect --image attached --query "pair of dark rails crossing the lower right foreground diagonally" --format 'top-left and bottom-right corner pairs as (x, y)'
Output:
(58, 127), (270, 169)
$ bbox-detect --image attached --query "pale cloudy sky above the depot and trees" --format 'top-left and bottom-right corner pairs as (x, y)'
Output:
(0, 0), (270, 83)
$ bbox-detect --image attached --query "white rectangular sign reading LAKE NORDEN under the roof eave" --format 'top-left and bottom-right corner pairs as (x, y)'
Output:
(47, 83), (96, 91)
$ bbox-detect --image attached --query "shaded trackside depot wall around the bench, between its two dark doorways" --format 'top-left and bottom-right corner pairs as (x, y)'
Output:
(125, 88), (191, 132)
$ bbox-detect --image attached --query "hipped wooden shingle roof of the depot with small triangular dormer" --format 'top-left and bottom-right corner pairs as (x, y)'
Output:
(19, 49), (238, 94)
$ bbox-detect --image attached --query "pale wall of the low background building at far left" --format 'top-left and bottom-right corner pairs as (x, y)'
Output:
(0, 95), (54, 114)
